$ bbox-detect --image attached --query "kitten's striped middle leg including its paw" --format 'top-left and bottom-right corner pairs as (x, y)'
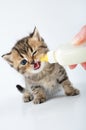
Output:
(31, 86), (46, 104)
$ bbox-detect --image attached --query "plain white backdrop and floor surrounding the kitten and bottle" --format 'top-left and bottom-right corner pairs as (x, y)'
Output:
(0, 0), (86, 130)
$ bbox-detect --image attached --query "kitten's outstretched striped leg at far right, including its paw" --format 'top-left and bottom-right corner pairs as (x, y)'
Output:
(61, 79), (80, 96)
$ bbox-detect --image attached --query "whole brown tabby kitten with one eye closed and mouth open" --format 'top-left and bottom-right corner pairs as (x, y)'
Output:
(2, 28), (79, 104)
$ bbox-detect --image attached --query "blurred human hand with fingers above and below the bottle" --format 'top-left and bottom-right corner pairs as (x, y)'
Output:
(69, 25), (86, 70)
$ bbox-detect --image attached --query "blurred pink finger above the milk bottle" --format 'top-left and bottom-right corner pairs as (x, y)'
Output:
(72, 25), (86, 45)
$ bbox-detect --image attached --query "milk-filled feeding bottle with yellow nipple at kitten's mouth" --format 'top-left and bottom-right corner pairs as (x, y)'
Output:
(40, 43), (86, 66)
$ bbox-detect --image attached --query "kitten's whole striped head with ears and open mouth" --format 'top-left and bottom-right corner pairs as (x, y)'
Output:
(2, 28), (48, 75)
